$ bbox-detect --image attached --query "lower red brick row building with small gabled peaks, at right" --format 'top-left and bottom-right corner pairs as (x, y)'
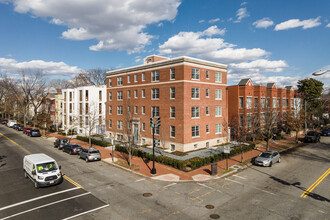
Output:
(228, 79), (294, 134)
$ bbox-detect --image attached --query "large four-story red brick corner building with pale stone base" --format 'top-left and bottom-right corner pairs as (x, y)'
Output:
(107, 55), (228, 152)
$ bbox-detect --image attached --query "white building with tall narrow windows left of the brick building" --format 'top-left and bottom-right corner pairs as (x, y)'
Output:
(62, 85), (106, 136)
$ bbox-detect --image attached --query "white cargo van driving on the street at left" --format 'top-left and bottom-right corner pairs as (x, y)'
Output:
(23, 154), (63, 188)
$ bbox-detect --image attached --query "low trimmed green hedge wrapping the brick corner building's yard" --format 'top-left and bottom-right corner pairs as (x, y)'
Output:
(116, 144), (255, 170)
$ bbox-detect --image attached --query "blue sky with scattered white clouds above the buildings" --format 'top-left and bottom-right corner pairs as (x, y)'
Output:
(0, 0), (330, 88)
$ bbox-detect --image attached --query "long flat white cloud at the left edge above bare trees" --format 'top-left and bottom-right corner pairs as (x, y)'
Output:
(0, 58), (81, 76)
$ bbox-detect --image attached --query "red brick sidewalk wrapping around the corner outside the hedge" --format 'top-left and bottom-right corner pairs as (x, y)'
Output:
(45, 133), (302, 180)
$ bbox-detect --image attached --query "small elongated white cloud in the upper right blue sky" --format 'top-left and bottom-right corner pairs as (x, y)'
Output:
(274, 16), (321, 31)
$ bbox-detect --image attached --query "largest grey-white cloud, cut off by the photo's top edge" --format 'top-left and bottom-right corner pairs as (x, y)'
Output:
(10, 0), (181, 53)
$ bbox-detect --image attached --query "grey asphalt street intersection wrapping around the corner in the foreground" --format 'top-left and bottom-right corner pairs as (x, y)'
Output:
(0, 126), (330, 219)
